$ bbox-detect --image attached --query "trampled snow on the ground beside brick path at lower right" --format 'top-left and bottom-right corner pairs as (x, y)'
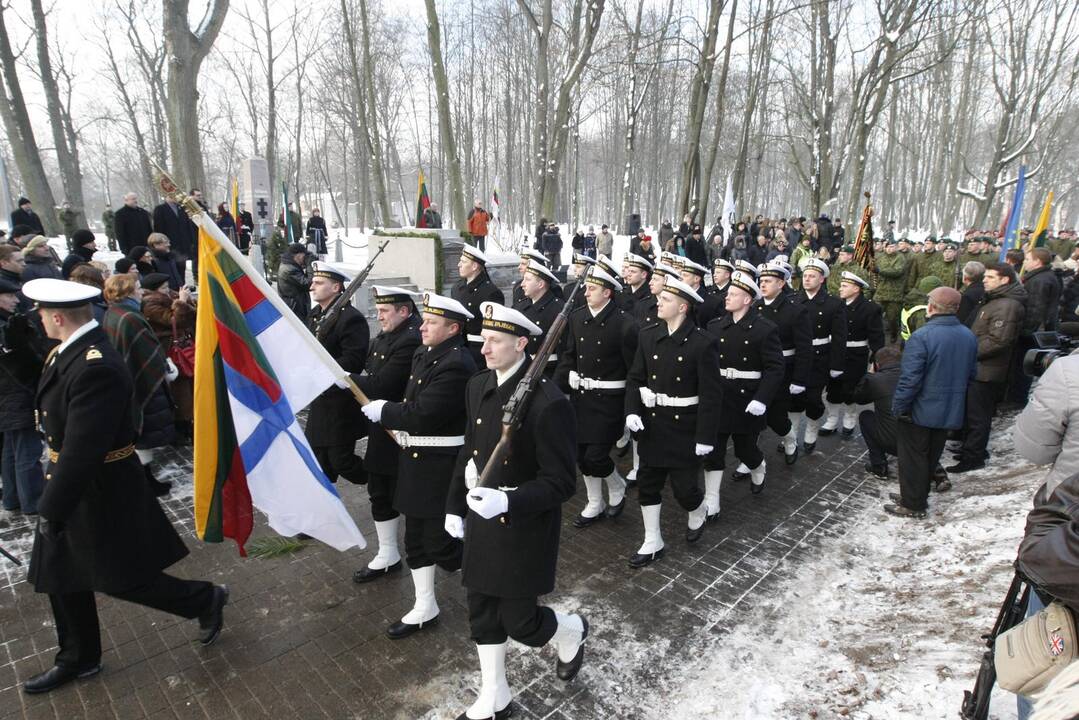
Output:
(646, 418), (1044, 720)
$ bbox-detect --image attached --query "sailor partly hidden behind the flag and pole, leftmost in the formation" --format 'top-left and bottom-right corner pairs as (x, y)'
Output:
(303, 260), (371, 485)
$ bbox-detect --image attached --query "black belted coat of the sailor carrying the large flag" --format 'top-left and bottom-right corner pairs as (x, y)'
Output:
(381, 335), (476, 518)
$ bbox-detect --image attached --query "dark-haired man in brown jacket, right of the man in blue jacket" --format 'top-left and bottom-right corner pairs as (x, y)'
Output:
(945, 262), (1026, 473)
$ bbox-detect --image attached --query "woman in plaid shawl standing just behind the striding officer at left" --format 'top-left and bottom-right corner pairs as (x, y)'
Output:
(101, 275), (176, 497)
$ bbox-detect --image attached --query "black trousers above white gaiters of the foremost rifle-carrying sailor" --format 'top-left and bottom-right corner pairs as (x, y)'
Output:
(468, 590), (558, 648)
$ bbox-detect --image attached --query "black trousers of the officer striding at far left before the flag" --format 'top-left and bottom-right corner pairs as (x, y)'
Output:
(49, 572), (214, 670)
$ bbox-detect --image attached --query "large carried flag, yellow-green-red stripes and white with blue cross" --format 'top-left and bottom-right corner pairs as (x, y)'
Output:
(192, 222), (365, 554)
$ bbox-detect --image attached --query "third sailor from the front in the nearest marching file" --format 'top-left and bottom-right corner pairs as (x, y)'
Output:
(705, 271), (784, 505)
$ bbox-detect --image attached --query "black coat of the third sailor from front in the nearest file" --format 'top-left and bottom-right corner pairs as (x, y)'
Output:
(707, 308), (784, 433)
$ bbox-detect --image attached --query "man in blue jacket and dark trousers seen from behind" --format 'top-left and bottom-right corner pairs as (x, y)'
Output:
(884, 287), (978, 518)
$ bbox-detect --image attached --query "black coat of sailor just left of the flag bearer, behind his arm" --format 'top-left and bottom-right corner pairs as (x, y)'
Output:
(353, 315), (420, 477)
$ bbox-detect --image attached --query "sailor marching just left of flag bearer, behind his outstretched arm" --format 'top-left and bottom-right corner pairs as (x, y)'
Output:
(352, 285), (420, 583)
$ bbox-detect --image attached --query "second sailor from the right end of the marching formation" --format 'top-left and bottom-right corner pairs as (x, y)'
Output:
(791, 258), (847, 454)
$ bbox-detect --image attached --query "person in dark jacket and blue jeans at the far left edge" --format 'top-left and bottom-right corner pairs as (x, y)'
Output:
(0, 280), (45, 515)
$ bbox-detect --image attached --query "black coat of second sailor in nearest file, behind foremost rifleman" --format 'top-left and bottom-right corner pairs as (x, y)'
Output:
(626, 318), (722, 467)
